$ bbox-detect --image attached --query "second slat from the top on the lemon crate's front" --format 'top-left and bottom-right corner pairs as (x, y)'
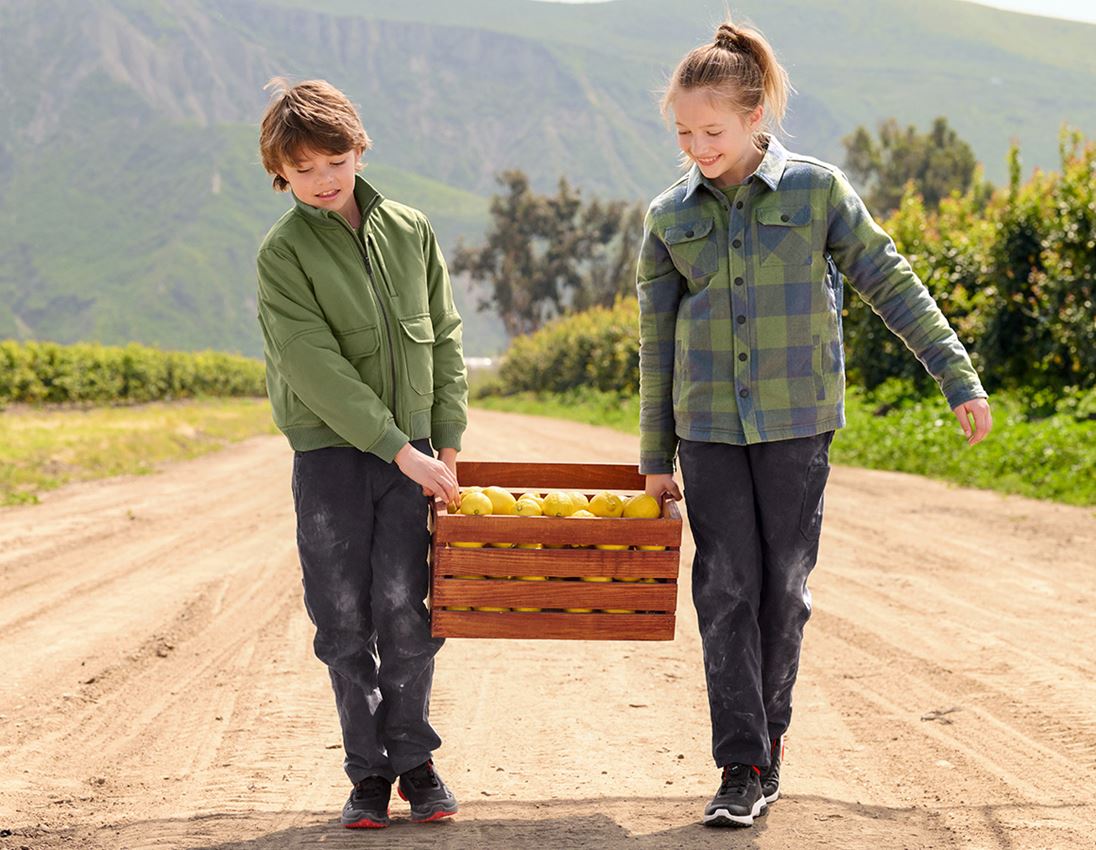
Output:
(433, 545), (681, 578)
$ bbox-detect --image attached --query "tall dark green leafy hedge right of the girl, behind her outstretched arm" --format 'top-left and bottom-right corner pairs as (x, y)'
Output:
(843, 129), (1096, 398)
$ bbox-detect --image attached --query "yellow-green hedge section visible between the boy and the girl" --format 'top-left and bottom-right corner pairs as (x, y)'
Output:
(498, 298), (639, 395)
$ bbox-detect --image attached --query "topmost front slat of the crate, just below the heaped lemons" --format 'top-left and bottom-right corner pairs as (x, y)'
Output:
(434, 513), (682, 547)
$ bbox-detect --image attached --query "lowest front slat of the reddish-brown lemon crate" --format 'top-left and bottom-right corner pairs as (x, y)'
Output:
(431, 610), (674, 641)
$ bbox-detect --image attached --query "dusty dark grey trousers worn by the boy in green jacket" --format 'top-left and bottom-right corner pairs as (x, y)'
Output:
(293, 439), (444, 782)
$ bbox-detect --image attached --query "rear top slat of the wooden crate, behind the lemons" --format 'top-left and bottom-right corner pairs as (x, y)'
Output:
(457, 460), (647, 492)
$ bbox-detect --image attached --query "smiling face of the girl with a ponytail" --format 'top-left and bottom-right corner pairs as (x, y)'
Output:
(673, 89), (763, 187)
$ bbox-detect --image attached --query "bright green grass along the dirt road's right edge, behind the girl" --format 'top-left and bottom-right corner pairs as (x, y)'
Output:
(473, 388), (1096, 506)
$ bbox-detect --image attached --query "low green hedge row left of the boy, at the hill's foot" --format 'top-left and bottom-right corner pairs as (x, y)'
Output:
(0, 340), (266, 405)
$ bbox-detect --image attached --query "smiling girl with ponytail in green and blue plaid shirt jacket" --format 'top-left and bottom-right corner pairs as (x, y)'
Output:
(637, 22), (991, 826)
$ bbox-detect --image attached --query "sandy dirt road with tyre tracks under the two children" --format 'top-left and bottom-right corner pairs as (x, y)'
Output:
(0, 411), (1096, 850)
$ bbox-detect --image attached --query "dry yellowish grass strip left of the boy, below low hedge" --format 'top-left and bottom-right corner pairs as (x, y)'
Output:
(0, 399), (277, 505)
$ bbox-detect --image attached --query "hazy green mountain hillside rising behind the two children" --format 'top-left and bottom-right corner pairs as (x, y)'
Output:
(0, 0), (1096, 355)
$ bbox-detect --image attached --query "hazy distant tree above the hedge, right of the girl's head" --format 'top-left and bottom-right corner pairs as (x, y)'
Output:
(842, 117), (991, 216)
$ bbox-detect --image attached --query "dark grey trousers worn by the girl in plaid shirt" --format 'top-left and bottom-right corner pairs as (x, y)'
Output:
(678, 432), (833, 768)
